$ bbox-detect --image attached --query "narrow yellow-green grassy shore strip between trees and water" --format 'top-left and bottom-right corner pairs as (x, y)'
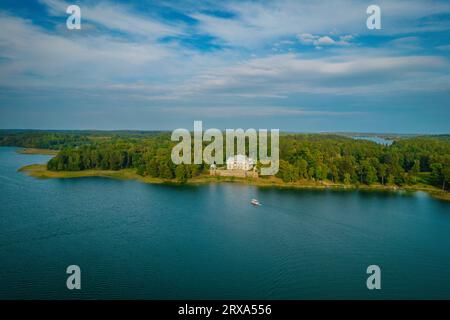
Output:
(18, 164), (450, 201)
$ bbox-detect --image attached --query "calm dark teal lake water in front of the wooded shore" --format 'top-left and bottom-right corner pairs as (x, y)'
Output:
(0, 147), (450, 299)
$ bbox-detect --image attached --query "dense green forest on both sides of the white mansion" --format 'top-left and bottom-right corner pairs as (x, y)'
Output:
(0, 130), (450, 190)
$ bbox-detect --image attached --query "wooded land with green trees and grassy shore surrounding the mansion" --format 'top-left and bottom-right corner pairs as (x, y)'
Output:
(0, 130), (450, 200)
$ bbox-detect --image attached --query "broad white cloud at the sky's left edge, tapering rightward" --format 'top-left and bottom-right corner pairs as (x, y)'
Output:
(0, 13), (171, 86)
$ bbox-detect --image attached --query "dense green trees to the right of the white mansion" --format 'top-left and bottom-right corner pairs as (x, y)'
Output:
(278, 135), (450, 189)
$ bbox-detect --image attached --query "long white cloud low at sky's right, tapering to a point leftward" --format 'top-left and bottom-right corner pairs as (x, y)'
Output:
(166, 50), (449, 97)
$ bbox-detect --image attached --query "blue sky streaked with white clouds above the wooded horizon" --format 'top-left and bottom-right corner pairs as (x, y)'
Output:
(0, 0), (450, 133)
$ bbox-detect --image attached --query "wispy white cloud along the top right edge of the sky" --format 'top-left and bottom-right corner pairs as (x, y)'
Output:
(191, 0), (450, 47)
